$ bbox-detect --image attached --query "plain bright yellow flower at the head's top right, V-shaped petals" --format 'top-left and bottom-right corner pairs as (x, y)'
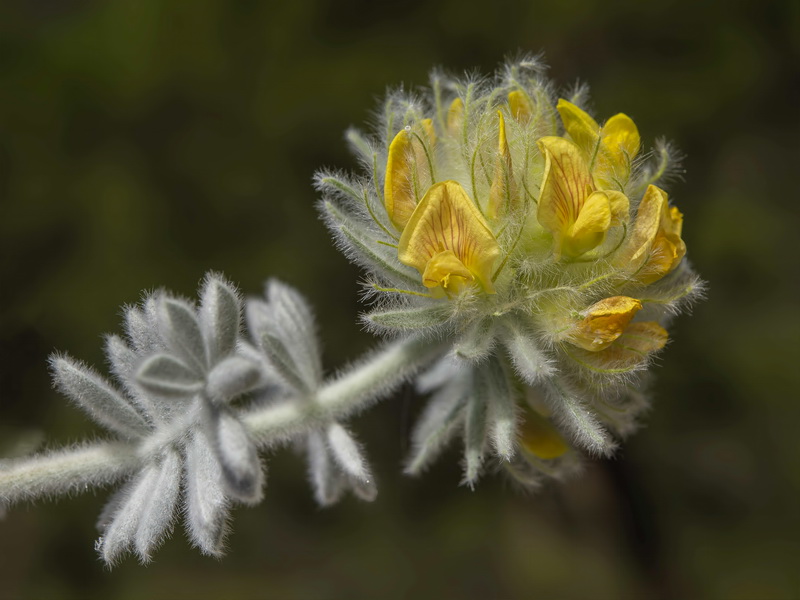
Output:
(556, 98), (641, 189)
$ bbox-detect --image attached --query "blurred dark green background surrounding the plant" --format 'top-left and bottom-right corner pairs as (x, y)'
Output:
(0, 0), (800, 599)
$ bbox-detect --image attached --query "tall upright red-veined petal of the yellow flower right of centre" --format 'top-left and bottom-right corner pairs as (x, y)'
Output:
(536, 137), (593, 248)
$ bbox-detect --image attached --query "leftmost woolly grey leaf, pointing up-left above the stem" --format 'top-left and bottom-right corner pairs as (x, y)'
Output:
(50, 356), (150, 438)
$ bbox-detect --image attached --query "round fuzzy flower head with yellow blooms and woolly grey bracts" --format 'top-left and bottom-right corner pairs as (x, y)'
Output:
(318, 58), (702, 485)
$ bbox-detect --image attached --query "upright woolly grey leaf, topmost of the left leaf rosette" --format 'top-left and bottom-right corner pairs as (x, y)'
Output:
(199, 273), (242, 365)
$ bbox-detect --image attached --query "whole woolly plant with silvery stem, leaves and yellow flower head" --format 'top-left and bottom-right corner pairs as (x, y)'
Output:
(0, 59), (702, 563)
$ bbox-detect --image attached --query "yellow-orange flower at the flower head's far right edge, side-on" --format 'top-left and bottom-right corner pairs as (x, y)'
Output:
(615, 185), (686, 285)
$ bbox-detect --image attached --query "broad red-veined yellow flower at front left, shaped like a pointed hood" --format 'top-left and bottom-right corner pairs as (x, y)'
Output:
(398, 181), (500, 295)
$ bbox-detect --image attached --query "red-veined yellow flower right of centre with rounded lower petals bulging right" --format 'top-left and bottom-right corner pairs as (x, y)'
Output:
(536, 137), (629, 258)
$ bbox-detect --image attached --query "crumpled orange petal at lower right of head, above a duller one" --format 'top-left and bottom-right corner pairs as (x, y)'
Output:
(569, 296), (642, 352)
